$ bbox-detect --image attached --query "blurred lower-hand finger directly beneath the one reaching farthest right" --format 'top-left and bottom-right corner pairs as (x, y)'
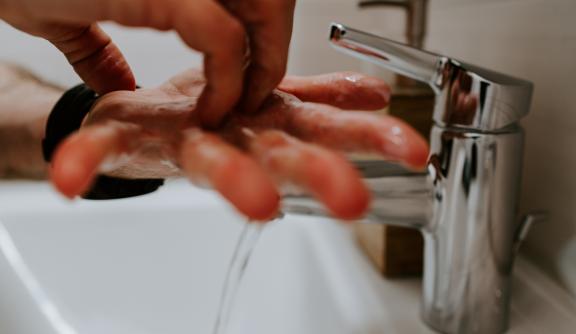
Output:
(250, 131), (370, 220)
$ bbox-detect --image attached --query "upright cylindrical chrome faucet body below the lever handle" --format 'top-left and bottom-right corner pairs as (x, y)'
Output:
(423, 126), (524, 334)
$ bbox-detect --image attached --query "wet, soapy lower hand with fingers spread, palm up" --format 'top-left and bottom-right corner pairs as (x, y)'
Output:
(51, 71), (428, 220)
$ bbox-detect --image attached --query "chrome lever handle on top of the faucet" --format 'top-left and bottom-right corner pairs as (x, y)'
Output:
(330, 23), (533, 132)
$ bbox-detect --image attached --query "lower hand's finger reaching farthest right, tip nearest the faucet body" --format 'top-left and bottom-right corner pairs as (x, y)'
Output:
(283, 103), (428, 169)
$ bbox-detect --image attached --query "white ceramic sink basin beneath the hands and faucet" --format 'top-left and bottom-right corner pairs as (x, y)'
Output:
(0, 181), (576, 334)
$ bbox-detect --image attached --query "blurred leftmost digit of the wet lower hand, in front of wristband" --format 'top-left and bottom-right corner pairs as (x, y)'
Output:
(50, 122), (139, 198)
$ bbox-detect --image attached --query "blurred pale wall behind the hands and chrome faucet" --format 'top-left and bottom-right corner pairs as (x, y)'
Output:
(0, 0), (576, 295)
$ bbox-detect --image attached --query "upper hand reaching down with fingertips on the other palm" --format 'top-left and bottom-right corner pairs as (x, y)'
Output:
(0, 0), (295, 127)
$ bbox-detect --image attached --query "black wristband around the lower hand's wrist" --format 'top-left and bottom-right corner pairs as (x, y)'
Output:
(42, 84), (164, 200)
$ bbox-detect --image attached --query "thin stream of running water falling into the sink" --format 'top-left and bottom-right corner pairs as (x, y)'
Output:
(212, 222), (263, 334)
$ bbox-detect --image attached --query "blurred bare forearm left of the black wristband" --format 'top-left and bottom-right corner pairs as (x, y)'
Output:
(0, 63), (63, 178)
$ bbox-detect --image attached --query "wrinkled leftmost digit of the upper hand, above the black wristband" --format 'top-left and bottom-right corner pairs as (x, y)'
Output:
(49, 24), (136, 94)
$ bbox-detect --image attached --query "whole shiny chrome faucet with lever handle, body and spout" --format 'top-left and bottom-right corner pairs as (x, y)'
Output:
(284, 24), (535, 334)
